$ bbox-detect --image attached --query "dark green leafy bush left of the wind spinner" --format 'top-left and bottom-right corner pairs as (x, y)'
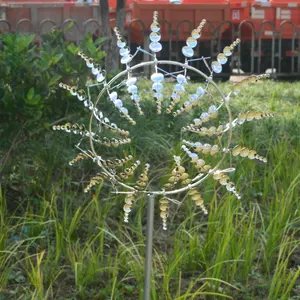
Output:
(0, 30), (104, 170)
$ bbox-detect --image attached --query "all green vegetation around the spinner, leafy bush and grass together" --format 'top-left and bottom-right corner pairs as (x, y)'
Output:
(0, 32), (300, 300)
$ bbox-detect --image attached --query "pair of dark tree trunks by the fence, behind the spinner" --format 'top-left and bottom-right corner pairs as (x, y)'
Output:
(99, 0), (126, 71)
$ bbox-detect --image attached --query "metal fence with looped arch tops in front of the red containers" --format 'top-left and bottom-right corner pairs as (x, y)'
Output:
(0, 19), (300, 77)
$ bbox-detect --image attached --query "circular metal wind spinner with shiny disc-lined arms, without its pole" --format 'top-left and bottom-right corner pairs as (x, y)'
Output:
(53, 12), (271, 230)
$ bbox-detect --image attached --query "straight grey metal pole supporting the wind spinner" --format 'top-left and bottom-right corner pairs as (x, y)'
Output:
(144, 195), (155, 300)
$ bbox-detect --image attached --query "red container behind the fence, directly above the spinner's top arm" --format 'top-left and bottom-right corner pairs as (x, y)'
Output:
(131, 0), (229, 43)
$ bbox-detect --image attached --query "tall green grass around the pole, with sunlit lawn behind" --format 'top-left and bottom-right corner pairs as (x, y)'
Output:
(0, 81), (300, 300)
